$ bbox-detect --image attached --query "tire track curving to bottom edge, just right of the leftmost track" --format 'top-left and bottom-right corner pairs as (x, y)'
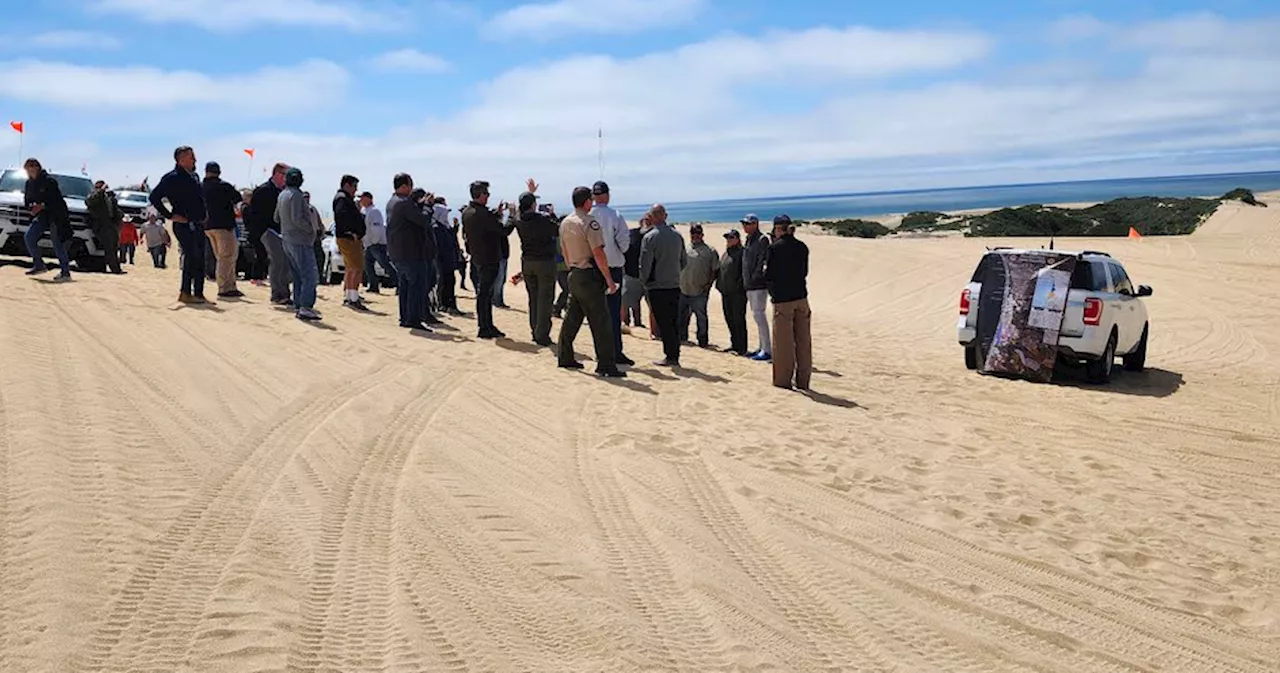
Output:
(287, 372), (467, 672)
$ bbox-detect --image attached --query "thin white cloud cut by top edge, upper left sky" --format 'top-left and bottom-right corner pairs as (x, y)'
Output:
(91, 0), (403, 31)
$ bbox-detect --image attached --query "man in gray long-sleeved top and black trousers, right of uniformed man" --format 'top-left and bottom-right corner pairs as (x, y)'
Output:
(640, 203), (689, 367)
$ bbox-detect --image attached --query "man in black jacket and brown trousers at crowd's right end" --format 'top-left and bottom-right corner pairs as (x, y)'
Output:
(764, 215), (813, 390)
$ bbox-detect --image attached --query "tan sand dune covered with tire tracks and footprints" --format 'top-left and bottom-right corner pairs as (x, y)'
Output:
(0, 198), (1280, 673)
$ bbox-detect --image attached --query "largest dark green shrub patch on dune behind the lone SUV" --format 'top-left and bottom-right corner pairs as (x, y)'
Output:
(968, 196), (1220, 237)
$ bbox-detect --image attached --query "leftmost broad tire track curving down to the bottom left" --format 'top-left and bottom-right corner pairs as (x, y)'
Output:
(70, 365), (390, 672)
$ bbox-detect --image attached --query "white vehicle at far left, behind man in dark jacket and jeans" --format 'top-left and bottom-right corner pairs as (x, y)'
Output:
(0, 169), (106, 271)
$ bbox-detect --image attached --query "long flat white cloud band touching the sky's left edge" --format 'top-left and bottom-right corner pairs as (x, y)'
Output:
(0, 59), (348, 114)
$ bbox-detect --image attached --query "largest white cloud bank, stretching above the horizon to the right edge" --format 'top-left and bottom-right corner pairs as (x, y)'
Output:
(22, 19), (1280, 211)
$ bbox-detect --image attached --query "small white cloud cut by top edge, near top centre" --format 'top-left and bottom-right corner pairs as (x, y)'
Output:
(490, 0), (707, 40)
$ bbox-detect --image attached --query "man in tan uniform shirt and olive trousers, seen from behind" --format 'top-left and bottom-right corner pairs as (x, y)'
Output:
(559, 187), (626, 379)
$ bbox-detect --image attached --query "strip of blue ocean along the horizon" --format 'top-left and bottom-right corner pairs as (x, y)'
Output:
(618, 171), (1280, 223)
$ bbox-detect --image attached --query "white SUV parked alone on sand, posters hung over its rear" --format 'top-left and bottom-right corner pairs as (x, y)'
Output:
(956, 248), (1152, 383)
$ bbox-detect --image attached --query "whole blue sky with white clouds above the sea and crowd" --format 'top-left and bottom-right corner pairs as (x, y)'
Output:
(0, 0), (1280, 212)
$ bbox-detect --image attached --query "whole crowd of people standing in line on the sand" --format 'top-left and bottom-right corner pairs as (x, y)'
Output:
(15, 146), (813, 390)
